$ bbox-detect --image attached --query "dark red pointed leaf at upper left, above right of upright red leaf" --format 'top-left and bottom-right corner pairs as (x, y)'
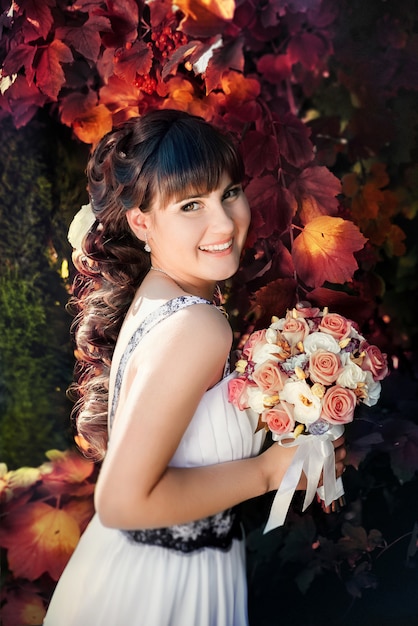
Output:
(55, 15), (111, 61)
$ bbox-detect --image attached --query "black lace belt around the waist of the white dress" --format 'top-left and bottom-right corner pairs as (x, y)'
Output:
(122, 509), (242, 553)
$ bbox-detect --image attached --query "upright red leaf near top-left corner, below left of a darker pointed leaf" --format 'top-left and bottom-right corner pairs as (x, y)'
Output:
(36, 39), (73, 100)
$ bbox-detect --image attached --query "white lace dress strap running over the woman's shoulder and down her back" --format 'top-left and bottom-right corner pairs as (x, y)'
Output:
(108, 296), (212, 431)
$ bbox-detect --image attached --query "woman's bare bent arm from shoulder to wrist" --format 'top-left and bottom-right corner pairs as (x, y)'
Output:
(95, 305), (346, 529)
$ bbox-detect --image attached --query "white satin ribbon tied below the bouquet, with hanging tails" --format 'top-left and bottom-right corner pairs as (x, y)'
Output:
(264, 424), (344, 533)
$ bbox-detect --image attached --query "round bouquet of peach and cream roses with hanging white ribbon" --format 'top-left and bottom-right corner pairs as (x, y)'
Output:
(228, 303), (388, 532)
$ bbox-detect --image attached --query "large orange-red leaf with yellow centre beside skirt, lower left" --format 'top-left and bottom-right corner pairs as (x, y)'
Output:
(0, 502), (80, 580)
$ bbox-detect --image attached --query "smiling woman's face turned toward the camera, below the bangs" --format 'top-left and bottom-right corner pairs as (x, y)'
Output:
(147, 174), (250, 293)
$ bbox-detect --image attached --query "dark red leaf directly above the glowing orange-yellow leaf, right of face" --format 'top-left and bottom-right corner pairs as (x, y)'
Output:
(290, 166), (341, 224)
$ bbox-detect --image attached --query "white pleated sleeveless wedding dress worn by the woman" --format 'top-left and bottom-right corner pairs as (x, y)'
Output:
(44, 296), (263, 626)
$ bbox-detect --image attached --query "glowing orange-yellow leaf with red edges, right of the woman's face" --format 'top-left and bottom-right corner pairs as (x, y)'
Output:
(292, 216), (366, 287)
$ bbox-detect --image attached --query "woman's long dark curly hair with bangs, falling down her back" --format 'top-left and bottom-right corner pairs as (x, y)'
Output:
(69, 110), (244, 461)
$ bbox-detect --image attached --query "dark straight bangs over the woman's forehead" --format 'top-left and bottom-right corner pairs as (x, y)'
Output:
(150, 120), (244, 206)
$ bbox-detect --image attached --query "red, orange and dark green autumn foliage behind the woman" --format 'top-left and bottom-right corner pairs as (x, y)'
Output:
(0, 0), (418, 626)
